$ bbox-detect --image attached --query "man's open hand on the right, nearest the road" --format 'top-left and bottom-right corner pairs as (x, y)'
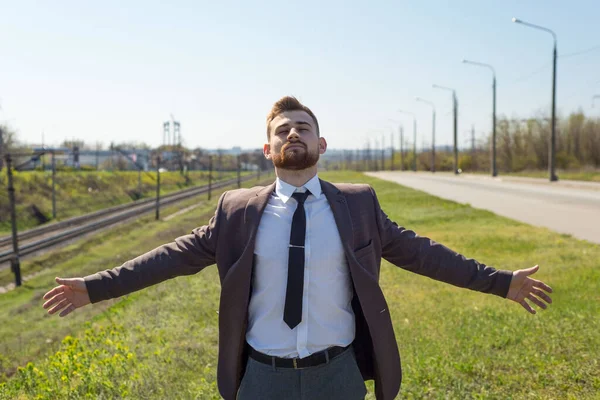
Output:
(506, 265), (552, 314)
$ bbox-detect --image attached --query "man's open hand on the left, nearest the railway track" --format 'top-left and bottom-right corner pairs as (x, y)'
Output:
(43, 278), (91, 317)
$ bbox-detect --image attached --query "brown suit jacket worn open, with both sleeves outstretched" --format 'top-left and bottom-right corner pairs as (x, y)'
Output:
(85, 181), (512, 400)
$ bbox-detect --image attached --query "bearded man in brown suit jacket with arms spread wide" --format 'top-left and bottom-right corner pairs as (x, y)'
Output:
(44, 97), (552, 400)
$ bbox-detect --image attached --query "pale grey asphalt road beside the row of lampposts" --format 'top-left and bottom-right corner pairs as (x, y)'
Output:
(368, 171), (600, 243)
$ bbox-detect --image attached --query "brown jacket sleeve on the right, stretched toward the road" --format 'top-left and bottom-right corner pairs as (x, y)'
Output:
(371, 188), (512, 297)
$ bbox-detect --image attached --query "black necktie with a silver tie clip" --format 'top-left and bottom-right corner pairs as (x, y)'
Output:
(283, 190), (310, 329)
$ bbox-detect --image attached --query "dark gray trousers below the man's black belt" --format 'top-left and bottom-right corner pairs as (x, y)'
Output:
(237, 347), (367, 400)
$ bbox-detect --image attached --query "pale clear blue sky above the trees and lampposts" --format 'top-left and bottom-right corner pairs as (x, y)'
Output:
(0, 0), (600, 148)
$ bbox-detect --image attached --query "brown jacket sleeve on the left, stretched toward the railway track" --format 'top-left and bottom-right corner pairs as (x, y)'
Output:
(84, 192), (227, 303)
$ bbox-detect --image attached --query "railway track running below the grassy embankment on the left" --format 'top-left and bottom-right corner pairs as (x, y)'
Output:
(0, 174), (256, 269)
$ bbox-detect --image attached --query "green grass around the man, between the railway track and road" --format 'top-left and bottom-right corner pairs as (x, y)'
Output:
(0, 173), (600, 399)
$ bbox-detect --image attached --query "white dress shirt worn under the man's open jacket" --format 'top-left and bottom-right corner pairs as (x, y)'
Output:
(246, 175), (355, 358)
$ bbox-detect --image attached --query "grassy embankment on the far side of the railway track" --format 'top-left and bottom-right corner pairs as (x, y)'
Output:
(0, 171), (245, 236)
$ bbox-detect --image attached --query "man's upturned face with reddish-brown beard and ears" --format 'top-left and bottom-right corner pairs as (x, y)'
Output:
(263, 110), (327, 170)
